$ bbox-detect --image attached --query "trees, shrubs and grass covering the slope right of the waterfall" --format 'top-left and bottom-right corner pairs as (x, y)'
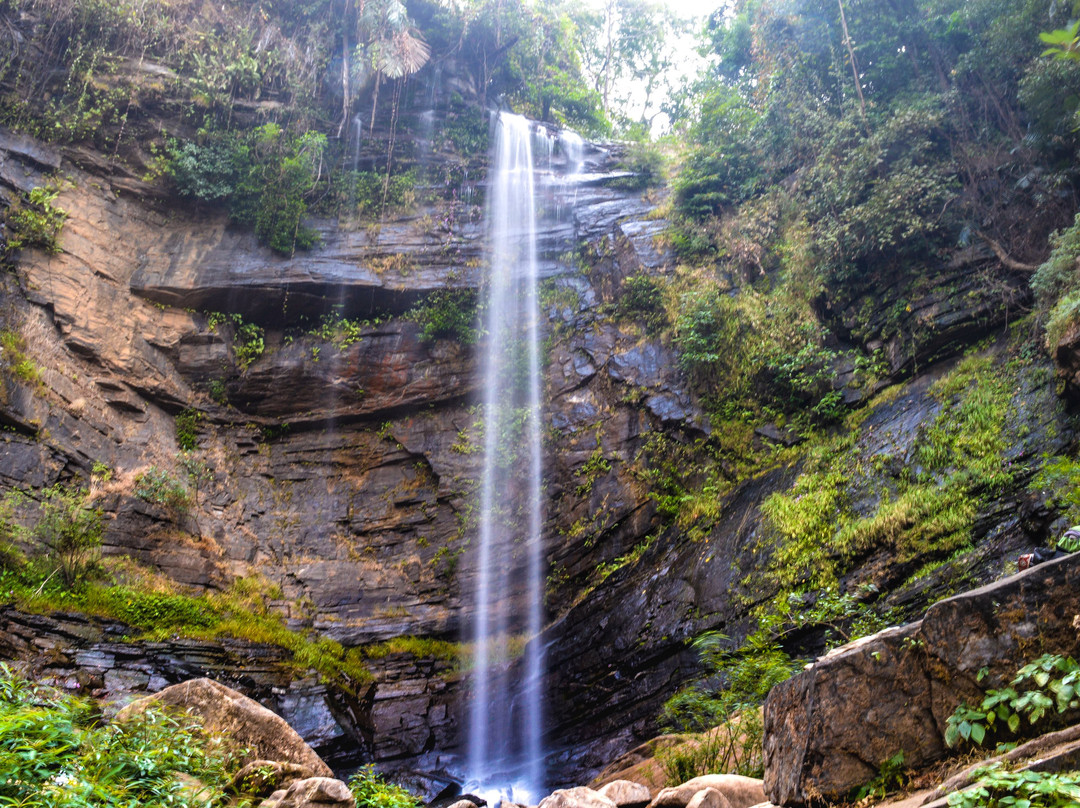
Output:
(624, 0), (1080, 773)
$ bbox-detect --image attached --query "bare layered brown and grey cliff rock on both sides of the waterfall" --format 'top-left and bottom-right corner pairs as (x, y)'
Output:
(0, 110), (1071, 782)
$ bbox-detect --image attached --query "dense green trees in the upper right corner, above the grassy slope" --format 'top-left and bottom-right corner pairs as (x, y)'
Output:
(674, 0), (1080, 285)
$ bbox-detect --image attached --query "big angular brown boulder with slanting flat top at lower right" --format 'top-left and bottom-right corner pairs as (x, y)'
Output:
(765, 554), (1080, 805)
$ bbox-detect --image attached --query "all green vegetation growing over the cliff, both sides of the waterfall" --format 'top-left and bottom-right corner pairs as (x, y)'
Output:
(0, 0), (1080, 790)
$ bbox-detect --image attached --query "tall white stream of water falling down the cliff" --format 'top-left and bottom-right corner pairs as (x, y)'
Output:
(467, 113), (544, 803)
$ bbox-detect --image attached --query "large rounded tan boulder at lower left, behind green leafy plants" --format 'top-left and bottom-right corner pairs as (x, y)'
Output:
(117, 678), (334, 782)
